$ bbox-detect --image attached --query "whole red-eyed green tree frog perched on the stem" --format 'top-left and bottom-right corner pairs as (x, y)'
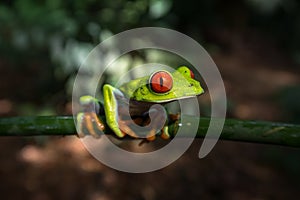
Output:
(77, 66), (204, 141)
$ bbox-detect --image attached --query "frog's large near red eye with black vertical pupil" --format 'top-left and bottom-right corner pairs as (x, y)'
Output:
(149, 71), (173, 93)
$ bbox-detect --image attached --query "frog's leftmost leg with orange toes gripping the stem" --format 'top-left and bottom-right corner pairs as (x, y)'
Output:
(76, 96), (104, 137)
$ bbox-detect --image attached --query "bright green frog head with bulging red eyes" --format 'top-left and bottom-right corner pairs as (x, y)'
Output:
(120, 66), (204, 103)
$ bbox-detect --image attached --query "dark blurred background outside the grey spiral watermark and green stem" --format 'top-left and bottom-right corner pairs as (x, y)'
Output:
(0, 0), (300, 200)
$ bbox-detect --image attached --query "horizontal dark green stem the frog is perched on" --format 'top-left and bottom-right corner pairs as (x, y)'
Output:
(0, 116), (300, 147)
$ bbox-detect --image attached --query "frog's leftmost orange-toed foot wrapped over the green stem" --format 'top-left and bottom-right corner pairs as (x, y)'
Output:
(77, 112), (105, 138)
